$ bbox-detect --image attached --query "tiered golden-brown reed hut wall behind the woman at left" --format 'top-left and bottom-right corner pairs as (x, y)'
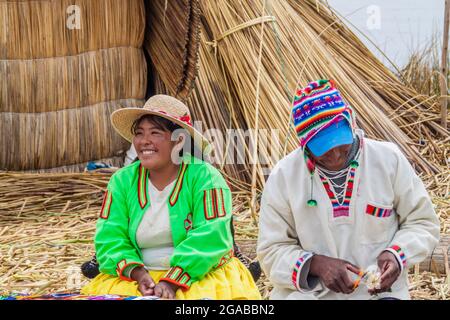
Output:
(0, 0), (147, 171)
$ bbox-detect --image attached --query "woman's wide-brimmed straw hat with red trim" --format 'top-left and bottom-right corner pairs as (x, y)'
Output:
(111, 94), (209, 152)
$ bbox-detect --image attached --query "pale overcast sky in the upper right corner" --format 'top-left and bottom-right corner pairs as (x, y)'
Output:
(328, 0), (445, 66)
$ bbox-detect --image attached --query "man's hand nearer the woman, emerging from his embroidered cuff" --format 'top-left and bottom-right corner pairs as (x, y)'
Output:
(309, 255), (360, 294)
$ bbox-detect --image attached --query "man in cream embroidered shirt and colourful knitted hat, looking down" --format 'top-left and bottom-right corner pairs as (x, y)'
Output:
(257, 80), (439, 299)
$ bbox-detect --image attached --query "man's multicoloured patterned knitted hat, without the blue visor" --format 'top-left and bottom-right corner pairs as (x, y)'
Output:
(292, 80), (356, 148)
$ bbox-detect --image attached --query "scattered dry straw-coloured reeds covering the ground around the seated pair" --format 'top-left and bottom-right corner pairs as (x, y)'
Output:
(0, 172), (450, 299)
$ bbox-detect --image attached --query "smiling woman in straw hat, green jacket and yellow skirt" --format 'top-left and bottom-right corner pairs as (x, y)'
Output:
(82, 95), (261, 299)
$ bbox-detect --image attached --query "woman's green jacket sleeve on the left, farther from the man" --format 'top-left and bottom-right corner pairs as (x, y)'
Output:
(95, 175), (144, 281)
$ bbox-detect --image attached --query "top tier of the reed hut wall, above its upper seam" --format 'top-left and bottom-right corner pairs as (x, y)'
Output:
(0, 0), (145, 60)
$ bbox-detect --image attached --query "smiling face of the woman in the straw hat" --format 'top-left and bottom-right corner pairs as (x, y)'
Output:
(133, 119), (181, 170)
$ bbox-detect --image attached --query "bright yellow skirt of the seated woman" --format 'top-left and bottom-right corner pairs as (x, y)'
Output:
(81, 258), (261, 300)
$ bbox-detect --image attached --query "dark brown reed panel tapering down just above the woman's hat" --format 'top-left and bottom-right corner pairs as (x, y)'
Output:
(144, 0), (200, 100)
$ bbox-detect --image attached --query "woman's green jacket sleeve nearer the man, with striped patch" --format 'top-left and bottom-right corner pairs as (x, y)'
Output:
(161, 165), (233, 290)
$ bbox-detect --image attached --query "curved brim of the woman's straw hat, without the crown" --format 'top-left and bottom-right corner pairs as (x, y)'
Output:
(111, 108), (211, 153)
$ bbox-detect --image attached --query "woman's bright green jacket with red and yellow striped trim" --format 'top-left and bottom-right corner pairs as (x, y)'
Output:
(95, 155), (233, 289)
